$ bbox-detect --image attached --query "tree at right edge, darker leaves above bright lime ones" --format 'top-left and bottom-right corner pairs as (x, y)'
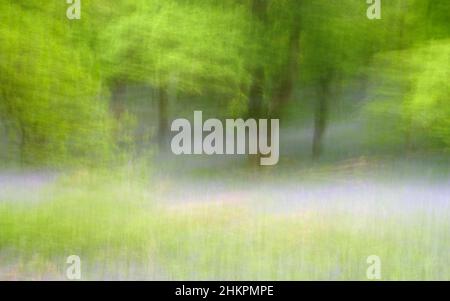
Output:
(365, 0), (450, 152)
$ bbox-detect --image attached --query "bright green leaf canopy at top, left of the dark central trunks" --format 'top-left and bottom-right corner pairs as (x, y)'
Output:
(102, 1), (249, 94)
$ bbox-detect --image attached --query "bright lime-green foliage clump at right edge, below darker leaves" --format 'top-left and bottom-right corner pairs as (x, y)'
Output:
(366, 40), (450, 149)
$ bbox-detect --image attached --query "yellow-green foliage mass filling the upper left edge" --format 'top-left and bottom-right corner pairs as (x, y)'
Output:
(0, 3), (111, 165)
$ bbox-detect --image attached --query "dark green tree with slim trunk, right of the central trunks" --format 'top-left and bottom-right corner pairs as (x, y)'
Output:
(300, 0), (400, 158)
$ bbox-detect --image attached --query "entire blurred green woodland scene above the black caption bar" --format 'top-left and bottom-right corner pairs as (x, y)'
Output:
(0, 0), (450, 280)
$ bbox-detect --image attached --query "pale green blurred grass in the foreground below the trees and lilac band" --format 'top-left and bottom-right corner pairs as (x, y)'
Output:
(0, 171), (450, 280)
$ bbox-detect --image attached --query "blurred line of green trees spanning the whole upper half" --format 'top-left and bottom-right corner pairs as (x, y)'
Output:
(0, 0), (450, 166)
